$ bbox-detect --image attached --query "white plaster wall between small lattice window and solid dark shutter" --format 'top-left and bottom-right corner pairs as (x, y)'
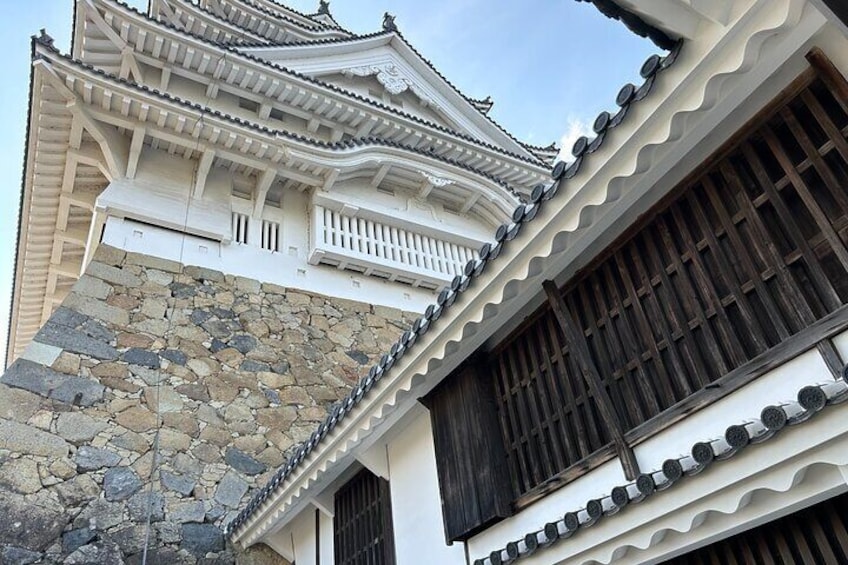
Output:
(388, 411), (465, 565)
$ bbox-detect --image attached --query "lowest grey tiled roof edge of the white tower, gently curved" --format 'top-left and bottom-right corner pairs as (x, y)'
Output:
(36, 39), (521, 196)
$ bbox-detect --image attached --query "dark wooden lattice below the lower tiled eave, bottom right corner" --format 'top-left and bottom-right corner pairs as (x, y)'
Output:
(666, 494), (848, 565)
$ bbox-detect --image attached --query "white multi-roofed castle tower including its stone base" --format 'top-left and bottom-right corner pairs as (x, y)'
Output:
(0, 0), (553, 563)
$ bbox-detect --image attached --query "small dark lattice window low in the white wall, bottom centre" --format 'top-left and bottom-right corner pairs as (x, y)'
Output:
(333, 470), (395, 565)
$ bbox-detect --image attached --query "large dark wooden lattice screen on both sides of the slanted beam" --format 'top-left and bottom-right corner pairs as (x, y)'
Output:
(490, 71), (848, 498)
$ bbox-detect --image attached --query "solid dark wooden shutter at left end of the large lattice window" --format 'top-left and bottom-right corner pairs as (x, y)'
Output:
(423, 362), (511, 542)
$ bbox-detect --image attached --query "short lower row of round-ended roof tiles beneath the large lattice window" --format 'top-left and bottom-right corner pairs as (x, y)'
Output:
(474, 374), (848, 565)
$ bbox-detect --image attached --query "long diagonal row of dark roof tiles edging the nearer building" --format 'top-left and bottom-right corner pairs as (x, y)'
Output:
(224, 37), (683, 537)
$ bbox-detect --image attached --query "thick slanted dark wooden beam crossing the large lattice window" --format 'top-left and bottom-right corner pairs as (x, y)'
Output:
(542, 281), (640, 481)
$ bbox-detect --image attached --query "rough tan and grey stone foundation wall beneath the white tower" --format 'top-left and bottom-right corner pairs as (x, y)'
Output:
(0, 247), (413, 564)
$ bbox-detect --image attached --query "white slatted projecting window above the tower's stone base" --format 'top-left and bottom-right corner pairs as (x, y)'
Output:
(309, 205), (476, 289)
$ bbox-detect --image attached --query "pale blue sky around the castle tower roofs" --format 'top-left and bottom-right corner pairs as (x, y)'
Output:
(0, 0), (657, 354)
